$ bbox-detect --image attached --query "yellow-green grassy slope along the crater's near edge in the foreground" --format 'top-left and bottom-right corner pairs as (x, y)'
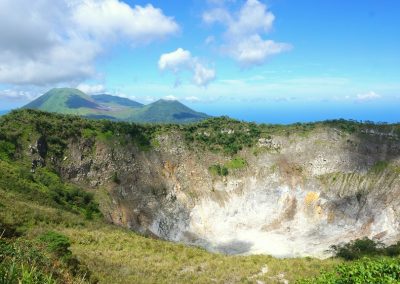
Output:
(62, 227), (339, 283)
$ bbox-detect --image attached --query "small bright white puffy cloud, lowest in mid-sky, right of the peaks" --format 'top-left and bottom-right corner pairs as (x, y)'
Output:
(158, 48), (216, 86)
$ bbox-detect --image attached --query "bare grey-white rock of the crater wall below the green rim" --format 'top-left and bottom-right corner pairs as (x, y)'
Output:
(54, 127), (400, 257)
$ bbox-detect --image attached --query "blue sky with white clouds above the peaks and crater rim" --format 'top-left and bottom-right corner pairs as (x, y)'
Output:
(0, 0), (400, 123)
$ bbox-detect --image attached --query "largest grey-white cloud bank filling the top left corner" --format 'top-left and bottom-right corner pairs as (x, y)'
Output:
(0, 0), (179, 85)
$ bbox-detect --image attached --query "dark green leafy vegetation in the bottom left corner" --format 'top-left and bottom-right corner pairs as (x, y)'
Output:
(0, 224), (97, 284)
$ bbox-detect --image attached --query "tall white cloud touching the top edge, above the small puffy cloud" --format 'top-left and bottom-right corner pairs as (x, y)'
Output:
(203, 0), (291, 67)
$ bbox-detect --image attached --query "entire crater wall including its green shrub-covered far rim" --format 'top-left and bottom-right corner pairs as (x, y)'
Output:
(0, 110), (400, 257)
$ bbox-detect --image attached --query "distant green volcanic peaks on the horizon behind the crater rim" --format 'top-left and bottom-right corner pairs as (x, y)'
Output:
(23, 88), (209, 123)
